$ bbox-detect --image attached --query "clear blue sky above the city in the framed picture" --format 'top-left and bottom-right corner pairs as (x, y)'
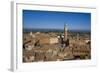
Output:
(23, 10), (91, 30)
